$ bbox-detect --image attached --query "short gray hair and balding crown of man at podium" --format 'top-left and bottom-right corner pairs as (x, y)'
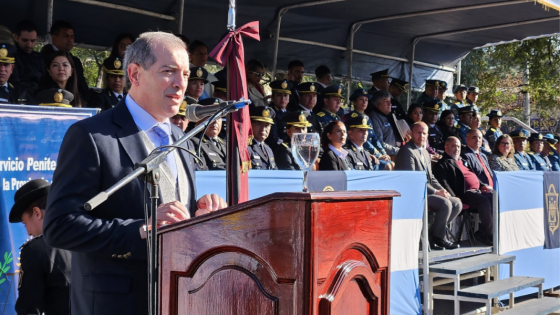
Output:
(123, 32), (187, 87)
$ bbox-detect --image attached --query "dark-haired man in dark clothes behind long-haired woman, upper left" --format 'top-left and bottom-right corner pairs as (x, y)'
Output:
(41, 21), (89, 102)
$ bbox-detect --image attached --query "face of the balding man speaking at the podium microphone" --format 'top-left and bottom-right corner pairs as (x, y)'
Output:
(128, 43), (189, 122)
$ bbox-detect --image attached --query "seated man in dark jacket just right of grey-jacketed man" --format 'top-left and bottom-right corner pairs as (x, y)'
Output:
(434, 137), (494, 246)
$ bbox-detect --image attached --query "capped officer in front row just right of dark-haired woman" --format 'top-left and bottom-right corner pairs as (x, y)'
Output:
(343, 114), (379, 171)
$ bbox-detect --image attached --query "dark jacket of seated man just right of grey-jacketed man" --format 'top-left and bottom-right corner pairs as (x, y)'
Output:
(434, 153), (482, 198)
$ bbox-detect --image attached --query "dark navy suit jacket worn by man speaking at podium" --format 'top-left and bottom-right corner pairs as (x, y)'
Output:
(43, 101), (196, 315)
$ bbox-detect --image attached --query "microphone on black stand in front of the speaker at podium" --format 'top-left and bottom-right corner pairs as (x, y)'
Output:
(84, 99), (250, 315)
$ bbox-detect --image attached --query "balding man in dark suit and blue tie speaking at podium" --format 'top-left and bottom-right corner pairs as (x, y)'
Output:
(43, 32), (225, 315)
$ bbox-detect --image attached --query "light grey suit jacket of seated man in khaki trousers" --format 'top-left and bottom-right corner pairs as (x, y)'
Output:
(395, 141), (443, 194)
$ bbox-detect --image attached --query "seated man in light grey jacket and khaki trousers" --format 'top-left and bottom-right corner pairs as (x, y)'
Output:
(395, 122), (463, 249)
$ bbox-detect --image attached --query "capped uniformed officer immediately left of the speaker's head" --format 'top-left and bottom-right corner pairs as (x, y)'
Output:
(88, 57), (126, 111)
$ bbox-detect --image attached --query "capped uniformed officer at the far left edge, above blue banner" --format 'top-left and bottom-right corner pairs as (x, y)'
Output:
(0, 43), (31, 104)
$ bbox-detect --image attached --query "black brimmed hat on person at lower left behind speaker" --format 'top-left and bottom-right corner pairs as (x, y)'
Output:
(9, 179), (51, 223)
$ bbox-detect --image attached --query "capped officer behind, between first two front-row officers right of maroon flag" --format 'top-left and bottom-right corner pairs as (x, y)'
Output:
(266, 80), (293, 150)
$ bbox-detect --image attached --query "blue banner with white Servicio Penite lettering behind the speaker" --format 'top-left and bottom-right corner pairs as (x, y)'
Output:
(0, 105), (97, 314)
